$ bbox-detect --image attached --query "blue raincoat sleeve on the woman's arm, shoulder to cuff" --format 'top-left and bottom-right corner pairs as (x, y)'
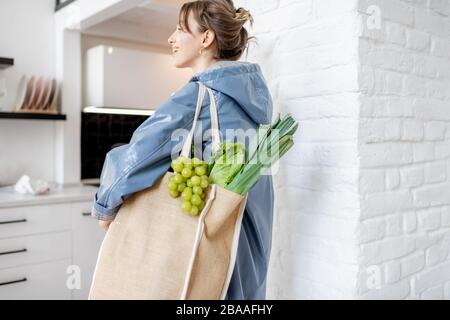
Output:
(91, 82), (198, 220)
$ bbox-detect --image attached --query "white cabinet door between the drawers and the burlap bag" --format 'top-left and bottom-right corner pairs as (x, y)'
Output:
(72, 202), (105, 300)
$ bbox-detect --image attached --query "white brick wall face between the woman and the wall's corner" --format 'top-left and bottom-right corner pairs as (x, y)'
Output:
(235, 0), (360, 299)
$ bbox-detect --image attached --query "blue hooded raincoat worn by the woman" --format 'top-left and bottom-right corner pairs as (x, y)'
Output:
(92, 61), (274, 300)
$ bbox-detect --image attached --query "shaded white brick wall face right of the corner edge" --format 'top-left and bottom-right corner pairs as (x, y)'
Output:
(357, 0), (450, 299)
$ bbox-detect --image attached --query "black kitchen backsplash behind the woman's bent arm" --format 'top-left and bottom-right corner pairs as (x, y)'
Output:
(81, 112), (148, 180)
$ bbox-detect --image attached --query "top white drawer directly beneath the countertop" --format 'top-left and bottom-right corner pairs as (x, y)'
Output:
(0, 204), (70, 239)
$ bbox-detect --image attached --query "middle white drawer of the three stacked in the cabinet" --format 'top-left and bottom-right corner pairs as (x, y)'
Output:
(0, 231), (72, 269)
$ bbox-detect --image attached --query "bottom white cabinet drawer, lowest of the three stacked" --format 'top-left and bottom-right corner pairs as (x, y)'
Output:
(0, 259), (72, 300)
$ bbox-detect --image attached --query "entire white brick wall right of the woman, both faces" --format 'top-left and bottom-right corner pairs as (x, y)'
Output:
(235, 0), (450, 299)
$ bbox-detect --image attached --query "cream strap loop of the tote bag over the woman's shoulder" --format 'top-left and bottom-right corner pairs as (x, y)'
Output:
(181, 82), (220, 158)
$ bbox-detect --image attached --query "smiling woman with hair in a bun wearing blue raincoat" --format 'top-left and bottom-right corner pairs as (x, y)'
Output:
(92, 0), (273, 299)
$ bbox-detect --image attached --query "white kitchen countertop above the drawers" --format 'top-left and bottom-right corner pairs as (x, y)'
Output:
(0, 184), (98, 208)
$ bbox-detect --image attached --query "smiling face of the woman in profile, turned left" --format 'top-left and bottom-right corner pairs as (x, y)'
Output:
(167, 14), (203, 68)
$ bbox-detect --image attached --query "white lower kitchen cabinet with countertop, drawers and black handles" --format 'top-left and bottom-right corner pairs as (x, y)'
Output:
(0, 189), (104, 300)
